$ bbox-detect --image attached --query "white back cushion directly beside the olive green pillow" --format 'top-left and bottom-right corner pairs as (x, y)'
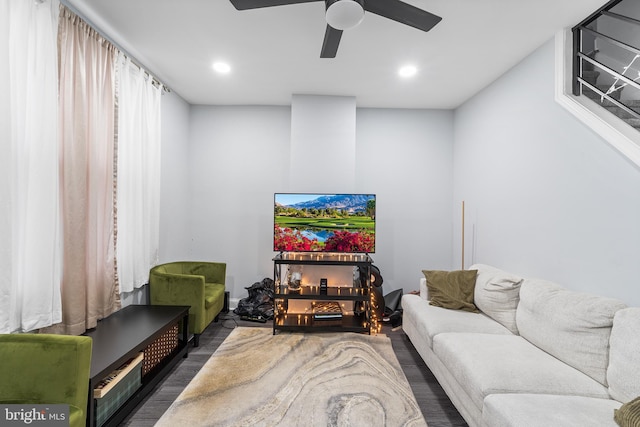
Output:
(470, 264), (522, 334)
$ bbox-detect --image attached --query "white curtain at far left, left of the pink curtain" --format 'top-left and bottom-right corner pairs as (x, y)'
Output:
(0, 0), (62, 333)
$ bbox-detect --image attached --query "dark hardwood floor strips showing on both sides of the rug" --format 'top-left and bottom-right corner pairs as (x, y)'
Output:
(120, 312), (467, 427)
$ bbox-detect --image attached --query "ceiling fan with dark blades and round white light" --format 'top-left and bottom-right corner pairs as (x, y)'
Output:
(230, 0), (442, 58)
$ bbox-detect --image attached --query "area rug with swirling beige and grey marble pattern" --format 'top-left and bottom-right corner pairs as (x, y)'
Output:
(156, 327), (427, 427)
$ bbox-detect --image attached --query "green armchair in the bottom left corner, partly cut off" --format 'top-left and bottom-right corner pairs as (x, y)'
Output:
(0, 334), (93, 427)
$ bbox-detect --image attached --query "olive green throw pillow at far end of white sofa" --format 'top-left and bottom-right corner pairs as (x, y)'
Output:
(422, 270), (478, 312)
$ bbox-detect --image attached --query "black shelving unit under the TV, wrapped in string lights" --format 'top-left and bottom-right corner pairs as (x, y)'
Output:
(273, 252), (373, 335)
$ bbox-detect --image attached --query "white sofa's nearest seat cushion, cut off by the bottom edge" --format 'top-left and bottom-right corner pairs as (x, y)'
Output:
(482, 394), (620, 427)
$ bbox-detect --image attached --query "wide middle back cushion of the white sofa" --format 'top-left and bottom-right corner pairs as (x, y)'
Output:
(516, 279), (625, 385)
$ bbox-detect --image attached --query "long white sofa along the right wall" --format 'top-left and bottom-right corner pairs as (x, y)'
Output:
(402, 264), (640, 427)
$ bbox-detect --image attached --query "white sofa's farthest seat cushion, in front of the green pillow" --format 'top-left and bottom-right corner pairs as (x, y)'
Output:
(402, 295), (511, 348)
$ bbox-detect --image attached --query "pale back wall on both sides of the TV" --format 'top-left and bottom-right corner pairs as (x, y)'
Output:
(181, 106), (453, 298)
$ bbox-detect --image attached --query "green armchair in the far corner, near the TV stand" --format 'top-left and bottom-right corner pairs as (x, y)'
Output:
(149, 261), (227, 347)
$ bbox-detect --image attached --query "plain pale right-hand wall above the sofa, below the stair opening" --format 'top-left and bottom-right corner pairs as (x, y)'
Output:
(453, 41), (640, 305)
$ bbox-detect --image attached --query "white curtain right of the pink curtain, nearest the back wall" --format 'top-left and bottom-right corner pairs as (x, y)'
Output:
(116, 54), (162, 292)
